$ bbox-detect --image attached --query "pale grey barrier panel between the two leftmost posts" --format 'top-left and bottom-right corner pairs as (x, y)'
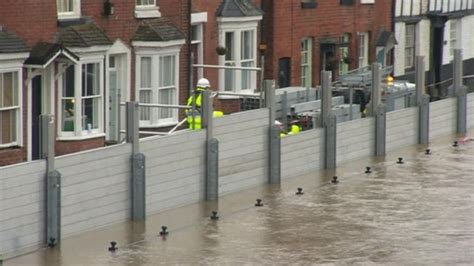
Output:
(56, 144), (131, 237)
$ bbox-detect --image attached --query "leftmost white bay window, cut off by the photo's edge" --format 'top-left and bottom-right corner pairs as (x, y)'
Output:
(0, 71), (21, 147)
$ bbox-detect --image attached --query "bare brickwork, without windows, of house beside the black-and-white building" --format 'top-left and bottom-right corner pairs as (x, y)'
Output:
(262, 0), (392, 86)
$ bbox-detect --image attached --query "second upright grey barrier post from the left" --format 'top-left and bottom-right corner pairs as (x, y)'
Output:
(126, 102), (146, 221)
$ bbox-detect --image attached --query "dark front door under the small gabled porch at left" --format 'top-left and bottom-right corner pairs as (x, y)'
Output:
(31, 75), (42, 160)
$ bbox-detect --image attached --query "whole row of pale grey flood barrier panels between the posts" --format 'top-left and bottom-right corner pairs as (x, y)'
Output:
(0, 90), (474, 256)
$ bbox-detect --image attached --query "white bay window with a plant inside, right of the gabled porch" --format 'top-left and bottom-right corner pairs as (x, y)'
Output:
(59, 61), (104, 138)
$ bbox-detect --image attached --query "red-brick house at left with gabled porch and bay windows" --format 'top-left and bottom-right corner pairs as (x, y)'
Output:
(0, 0), (190, 165)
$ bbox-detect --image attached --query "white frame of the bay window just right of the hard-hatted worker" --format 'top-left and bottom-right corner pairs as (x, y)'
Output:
(217, 16), (262, 94)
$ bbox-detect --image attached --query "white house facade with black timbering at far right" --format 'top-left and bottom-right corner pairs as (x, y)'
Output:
(394, 0), (474, 95)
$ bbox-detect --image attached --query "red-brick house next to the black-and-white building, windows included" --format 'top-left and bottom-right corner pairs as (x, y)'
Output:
(262, 0), (396, 87)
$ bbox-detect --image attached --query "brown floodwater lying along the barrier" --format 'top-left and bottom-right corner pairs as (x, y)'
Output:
(5, 132), (474, 265)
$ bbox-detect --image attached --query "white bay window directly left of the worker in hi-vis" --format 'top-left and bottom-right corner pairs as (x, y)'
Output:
(137, 53), (179, 127)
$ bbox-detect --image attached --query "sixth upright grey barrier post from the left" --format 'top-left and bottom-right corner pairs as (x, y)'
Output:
(371, 63), (387, 156)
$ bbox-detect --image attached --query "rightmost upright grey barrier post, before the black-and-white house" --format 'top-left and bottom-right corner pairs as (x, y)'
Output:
(453, 49), (467, 134)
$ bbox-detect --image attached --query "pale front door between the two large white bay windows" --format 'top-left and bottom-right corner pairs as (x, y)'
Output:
(109, 55), (124, 141)
